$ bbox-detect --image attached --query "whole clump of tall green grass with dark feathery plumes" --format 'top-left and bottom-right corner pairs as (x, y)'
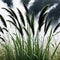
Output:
(0, 3), (60, 60)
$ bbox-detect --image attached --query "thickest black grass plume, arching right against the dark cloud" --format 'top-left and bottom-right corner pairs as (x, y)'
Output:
(38, 5), (49, 31)
